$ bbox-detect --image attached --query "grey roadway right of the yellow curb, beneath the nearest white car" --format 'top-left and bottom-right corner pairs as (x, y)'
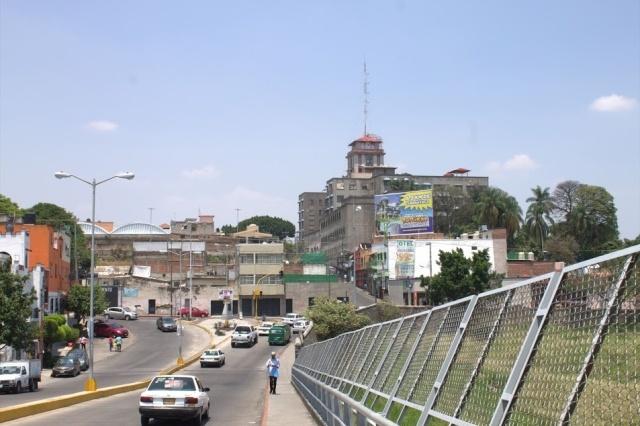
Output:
(5, 337), (280, 426)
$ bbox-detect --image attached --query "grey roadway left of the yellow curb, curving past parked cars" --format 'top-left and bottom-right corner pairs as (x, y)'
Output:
(0, 318), (209, 407)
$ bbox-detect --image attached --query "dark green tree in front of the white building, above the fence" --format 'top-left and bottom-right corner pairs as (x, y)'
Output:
(421, 248), (503, 305)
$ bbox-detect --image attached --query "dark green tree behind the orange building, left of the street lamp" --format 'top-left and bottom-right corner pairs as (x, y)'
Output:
(26, 203), (91, 276)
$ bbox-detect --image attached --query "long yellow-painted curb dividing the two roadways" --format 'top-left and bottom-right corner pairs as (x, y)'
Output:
(0, 324), (216, 423)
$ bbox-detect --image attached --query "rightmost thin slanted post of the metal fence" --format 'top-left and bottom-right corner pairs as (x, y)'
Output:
(560, 255), (638, 424)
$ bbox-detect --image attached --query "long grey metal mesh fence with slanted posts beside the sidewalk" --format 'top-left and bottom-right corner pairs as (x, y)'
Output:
(292, 246), (640, 426)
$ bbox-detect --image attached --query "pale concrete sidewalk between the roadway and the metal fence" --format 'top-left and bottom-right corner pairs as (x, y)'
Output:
(262, 344), (319, 426)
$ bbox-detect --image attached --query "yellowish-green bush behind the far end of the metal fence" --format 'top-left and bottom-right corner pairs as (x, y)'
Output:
(306, 297), (370, 340)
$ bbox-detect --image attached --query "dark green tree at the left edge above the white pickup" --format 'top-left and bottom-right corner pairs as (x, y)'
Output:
(0, 262), (37, 351)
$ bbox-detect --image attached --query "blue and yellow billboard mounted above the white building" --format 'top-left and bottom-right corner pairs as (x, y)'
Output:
(374, 189), (433, 235)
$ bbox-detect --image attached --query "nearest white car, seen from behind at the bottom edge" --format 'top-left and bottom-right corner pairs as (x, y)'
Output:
(138, 375), (211, 426)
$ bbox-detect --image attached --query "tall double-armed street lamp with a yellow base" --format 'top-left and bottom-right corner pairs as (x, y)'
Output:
(54, 171), (135, 391)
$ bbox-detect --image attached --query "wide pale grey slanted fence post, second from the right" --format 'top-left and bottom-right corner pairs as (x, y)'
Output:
(490, 263), (564, 426)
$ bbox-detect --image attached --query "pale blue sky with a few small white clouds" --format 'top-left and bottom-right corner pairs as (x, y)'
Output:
(0, 0), (640, 238)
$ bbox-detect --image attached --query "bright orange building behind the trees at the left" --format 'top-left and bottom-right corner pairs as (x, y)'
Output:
(0, 223), (71, 312)
